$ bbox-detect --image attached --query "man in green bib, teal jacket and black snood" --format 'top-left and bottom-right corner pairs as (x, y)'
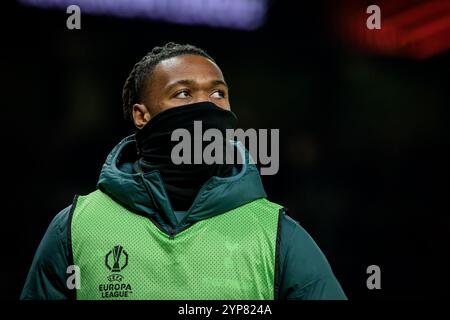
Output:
(21, 43), (346, 299)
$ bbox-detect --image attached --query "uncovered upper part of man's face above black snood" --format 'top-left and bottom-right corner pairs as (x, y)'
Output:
(133, 54), (230, 128)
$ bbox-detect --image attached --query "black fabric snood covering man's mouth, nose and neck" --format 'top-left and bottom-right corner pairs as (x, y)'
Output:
(135, 102), (237, 211)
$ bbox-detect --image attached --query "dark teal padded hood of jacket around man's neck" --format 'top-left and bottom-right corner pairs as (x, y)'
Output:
(97, 135), (266, 230)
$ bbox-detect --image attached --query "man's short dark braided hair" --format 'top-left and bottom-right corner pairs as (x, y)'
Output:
(122, 42), (214, 120)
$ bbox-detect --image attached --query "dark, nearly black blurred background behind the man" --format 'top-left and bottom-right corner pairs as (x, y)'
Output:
(0, 1), (450, 299)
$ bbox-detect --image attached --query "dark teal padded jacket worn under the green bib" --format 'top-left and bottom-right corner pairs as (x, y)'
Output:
(21, 136), (346, 300)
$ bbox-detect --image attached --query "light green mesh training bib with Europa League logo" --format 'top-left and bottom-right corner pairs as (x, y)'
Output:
(71, 190), (281, 300)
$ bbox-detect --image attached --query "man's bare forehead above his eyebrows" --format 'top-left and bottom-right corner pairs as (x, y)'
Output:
(152, 54), (224, 85)
